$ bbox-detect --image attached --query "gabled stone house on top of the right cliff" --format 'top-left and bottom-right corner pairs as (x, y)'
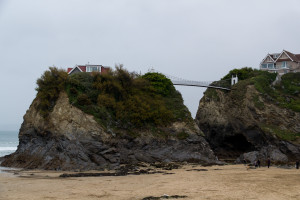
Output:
(260, 50), (300, 75)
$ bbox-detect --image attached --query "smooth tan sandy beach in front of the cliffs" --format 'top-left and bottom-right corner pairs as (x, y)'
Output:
(0, 165), (300, 200)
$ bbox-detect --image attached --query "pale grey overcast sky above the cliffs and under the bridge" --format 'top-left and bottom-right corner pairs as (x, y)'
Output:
(0, 0), (300, 130)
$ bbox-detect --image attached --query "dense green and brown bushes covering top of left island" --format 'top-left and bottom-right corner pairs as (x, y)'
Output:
(36, 66), (193, 129)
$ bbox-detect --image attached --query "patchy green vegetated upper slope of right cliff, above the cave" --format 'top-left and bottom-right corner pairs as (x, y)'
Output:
(205, 67), (300, 143)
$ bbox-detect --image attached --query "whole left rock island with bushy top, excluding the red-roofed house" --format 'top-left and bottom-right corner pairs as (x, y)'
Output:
(1, 67), (217, 170)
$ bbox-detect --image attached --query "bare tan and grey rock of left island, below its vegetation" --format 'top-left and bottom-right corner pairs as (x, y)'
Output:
(2, 92), (216, 170)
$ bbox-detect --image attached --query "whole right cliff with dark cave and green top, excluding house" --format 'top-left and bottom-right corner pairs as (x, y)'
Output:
(196, 70), (300, 163)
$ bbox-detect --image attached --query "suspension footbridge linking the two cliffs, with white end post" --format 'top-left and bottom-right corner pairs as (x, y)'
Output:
(149, 68), (238, 90)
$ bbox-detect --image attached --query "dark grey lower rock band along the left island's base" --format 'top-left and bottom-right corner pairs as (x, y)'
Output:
(2, 129), (215, 170)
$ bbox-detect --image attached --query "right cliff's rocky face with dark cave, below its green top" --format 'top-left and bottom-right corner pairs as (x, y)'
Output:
(196, 85), (300, 163)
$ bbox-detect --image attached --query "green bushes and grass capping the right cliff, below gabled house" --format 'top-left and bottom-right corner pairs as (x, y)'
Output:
(205, 67), (300, 112)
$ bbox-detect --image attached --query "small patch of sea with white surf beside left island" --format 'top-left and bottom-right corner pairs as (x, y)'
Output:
(0, 131), (19, 157)
